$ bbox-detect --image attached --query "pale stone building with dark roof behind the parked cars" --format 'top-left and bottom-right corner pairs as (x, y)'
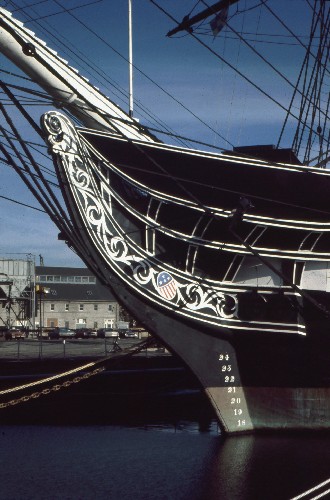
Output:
(35, 266), (119, 329)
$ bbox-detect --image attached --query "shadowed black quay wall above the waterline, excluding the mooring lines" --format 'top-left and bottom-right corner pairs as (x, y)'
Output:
(0, 353), (215, 430)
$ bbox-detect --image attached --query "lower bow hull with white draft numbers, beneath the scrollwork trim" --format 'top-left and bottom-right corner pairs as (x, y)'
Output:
(104, 283), (330, 434)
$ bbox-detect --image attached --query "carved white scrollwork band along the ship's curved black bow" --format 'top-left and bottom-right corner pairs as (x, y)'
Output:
(42, 111), (237, 320)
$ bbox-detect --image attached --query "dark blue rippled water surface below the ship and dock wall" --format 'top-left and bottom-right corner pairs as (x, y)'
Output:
(0, 421), (330, 500)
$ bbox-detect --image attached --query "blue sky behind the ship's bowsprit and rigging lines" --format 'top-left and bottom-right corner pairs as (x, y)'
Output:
(0, 0), (320, 266)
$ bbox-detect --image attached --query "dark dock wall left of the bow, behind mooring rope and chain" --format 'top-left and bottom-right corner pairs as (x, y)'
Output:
(0, 339), (214, 425)
